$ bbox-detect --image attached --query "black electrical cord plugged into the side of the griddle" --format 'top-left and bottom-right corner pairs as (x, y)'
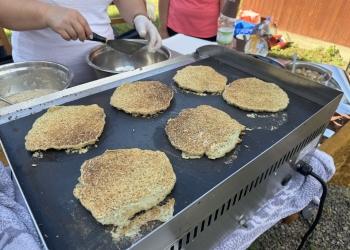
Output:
(297, 162), (327, 250)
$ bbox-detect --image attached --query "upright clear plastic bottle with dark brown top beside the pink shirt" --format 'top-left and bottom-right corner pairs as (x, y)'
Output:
(216, 0), (240, 49)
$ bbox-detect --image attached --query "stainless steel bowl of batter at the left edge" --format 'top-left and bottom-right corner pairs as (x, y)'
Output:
(0, 61), (74, 98)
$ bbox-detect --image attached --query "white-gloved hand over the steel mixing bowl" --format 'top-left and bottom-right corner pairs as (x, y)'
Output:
(134, 15), (162, 53)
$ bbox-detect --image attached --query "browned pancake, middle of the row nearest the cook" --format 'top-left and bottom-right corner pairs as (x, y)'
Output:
(111, 81), (174, 116)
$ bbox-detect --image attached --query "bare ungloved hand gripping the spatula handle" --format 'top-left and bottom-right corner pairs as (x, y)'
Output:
(45, 6), (92, 42)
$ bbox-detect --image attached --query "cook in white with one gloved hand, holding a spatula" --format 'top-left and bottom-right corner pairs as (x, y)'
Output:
(0, 0), (162, 86)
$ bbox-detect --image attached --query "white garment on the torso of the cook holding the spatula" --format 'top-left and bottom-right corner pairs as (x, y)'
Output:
(11, 0), (114, 86)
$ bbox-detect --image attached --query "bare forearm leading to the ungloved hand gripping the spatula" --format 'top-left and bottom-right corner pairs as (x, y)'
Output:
(0, 0), (50, 30)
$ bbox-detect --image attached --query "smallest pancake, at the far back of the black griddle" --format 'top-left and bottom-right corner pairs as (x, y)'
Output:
(173, 66), (227, 94)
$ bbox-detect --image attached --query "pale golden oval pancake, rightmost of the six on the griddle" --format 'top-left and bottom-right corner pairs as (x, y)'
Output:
(222, 78), (289, 112)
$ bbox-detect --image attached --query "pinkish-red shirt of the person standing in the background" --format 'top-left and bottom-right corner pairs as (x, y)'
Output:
(168, 0), (220, 38)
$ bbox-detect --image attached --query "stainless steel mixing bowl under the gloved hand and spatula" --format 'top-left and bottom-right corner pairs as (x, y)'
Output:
(86, 39), (172, 78)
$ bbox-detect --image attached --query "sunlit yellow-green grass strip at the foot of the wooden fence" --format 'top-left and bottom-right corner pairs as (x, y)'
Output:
(268, 44), (346, 67)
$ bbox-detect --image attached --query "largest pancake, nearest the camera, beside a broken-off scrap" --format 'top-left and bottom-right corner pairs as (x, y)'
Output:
(73, 149), (176, 227)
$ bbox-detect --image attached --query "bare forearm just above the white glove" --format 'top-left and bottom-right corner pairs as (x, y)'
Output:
(113, 0), (148, 25)
